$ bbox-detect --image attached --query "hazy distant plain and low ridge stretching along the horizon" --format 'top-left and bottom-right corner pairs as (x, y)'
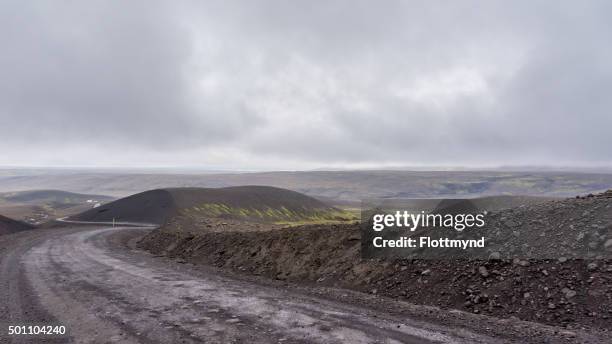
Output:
(0, 171), (612, 204)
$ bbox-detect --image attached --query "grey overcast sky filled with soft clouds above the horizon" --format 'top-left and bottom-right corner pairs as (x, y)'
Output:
(0, 0), (612, 170)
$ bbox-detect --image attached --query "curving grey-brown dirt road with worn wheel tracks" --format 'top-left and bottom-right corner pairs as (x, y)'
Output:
(0, 226), (596, 343)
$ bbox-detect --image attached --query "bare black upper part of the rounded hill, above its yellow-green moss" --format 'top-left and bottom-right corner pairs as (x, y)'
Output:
(71, 186), (333, 224)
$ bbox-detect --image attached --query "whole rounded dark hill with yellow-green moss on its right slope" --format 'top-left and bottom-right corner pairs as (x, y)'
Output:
(73, 186), (339, 226)
